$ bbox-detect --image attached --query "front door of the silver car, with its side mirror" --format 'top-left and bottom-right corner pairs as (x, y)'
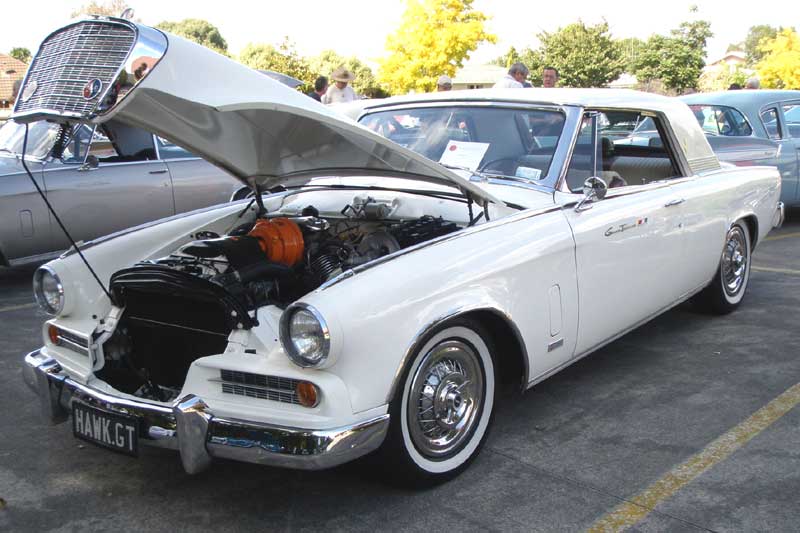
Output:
(44, 124), (174, 249)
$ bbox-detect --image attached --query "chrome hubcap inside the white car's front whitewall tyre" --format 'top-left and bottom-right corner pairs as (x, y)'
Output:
(407, 340), (484, 458)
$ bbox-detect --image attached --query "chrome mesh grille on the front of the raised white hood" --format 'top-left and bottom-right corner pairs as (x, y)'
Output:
(15, 21), (136, 116)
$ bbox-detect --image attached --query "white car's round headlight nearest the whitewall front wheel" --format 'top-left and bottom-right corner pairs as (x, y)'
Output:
(281, 304), (331, 368)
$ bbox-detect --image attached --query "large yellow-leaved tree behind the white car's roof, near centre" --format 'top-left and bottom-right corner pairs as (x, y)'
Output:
(378, 0), (497, 94)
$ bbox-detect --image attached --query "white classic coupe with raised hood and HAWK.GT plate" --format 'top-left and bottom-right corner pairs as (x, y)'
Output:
(20, 18), (783, 483)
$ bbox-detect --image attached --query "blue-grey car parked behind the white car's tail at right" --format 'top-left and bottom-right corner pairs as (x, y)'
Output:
(680, 90), (800, 206)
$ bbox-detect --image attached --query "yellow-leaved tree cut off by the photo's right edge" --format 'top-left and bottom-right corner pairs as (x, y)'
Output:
(756, 29), (800, 89)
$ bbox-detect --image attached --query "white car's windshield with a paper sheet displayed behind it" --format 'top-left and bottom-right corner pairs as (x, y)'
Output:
(360, 106), (565, 180)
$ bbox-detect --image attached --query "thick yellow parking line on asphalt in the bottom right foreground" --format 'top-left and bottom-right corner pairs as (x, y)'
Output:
(589, 383), (800, 533)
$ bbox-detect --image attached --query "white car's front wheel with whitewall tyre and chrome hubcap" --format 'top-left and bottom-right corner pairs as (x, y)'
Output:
(381, 320), (495, 485)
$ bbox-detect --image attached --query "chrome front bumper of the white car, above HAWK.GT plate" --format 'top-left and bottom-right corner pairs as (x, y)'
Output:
(23, 350), (389, 474)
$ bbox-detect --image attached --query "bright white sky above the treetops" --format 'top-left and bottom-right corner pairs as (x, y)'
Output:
(0, 0), (800, 69)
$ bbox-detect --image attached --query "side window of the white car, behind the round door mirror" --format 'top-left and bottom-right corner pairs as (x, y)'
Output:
(567, 111), (680, 192)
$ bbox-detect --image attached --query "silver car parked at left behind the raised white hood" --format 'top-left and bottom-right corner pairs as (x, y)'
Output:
(0, 117), (242, 266)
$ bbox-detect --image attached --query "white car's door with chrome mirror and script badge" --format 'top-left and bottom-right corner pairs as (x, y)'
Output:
(556, 110), (685, 356)
